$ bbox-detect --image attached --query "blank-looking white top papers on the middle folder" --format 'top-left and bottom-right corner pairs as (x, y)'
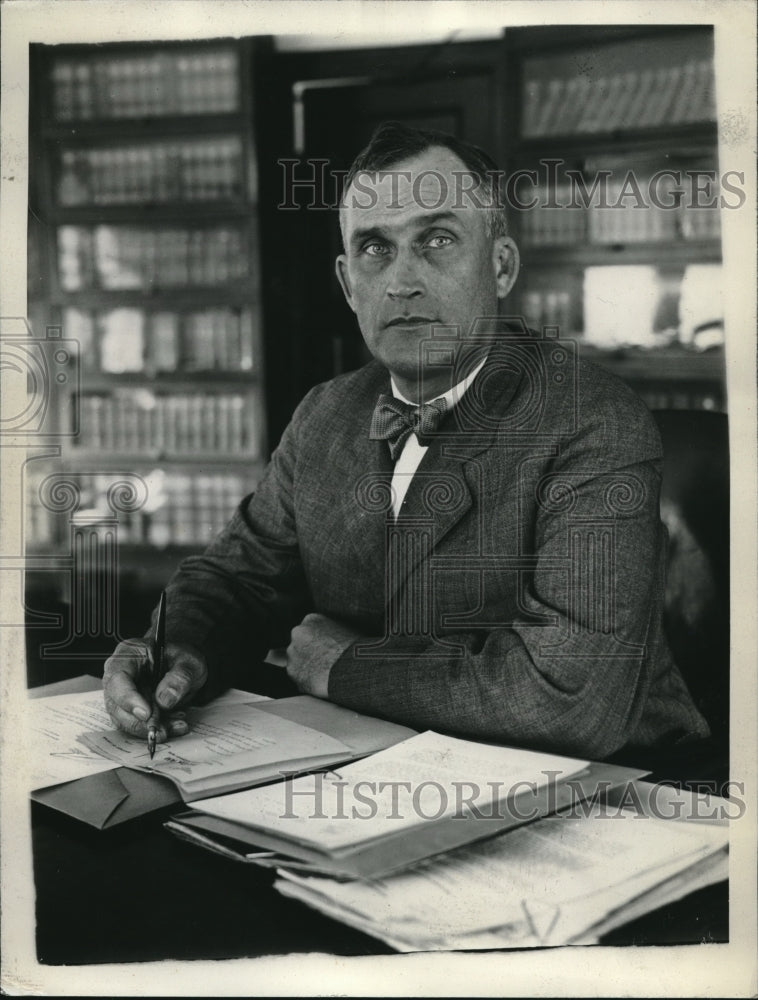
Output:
(192, 732), (587, 853)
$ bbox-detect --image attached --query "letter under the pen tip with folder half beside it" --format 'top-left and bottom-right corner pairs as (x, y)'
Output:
(80, 695), (413, 802)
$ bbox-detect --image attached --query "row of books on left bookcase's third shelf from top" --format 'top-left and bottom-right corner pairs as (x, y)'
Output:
(58, 226), (249, 292)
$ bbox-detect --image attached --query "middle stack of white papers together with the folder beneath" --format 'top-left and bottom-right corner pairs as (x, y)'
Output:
(169, 732), (642, 878)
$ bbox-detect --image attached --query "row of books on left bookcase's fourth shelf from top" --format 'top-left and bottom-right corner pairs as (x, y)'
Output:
(63, 307), (254, 376)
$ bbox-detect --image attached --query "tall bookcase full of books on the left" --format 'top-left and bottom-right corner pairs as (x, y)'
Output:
(28, 39), (266, 575)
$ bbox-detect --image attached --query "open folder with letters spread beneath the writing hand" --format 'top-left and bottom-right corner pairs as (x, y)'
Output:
(32, 679), (413, 829)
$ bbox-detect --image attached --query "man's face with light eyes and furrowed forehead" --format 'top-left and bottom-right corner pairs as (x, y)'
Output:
(337, 147), (518, 383)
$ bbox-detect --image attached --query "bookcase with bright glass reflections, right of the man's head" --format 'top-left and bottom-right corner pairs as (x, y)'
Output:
(503, 26), (726, 410)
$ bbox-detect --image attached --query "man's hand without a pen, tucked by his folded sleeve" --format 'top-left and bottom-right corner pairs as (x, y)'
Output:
(287, 614), (365, 698)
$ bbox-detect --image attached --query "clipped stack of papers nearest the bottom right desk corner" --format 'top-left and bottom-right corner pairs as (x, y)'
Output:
(275, 803), (728, 952)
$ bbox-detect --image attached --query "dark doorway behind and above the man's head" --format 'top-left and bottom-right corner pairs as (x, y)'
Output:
(263, 42), (502, 444)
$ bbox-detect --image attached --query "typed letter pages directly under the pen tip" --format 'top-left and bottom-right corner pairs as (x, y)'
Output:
(82, 702), (355, 802)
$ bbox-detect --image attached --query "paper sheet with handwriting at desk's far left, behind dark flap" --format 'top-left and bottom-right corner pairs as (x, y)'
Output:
(29, 688), (268, 790)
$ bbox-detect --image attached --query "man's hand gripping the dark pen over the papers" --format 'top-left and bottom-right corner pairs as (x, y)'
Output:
(103, 639), (208, 743)
